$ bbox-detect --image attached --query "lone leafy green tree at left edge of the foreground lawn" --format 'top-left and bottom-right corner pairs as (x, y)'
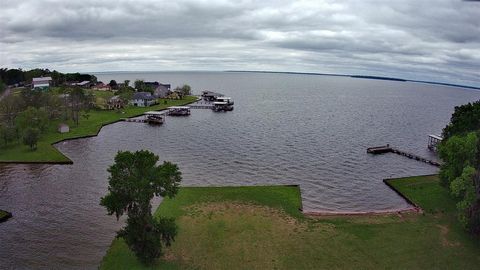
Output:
(100, 150), (182, 264)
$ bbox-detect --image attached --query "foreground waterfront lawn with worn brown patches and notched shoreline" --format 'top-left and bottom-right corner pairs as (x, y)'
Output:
(100, 176), (480, 269)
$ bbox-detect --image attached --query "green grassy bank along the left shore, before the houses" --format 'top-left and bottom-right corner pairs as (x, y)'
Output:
(0, 97), (196, 163)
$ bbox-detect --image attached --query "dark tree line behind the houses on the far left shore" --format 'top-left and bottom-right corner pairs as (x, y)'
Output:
(0, 68), (97, 87)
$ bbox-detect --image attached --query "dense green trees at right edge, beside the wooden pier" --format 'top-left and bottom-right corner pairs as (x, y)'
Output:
(438, 101), (480, 235)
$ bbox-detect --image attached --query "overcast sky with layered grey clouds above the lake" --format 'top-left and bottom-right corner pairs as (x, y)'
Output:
(0, 0), (480, 86)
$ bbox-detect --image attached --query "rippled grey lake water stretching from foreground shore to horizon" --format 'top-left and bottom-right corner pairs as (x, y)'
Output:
(0, 72), (480, 269)
